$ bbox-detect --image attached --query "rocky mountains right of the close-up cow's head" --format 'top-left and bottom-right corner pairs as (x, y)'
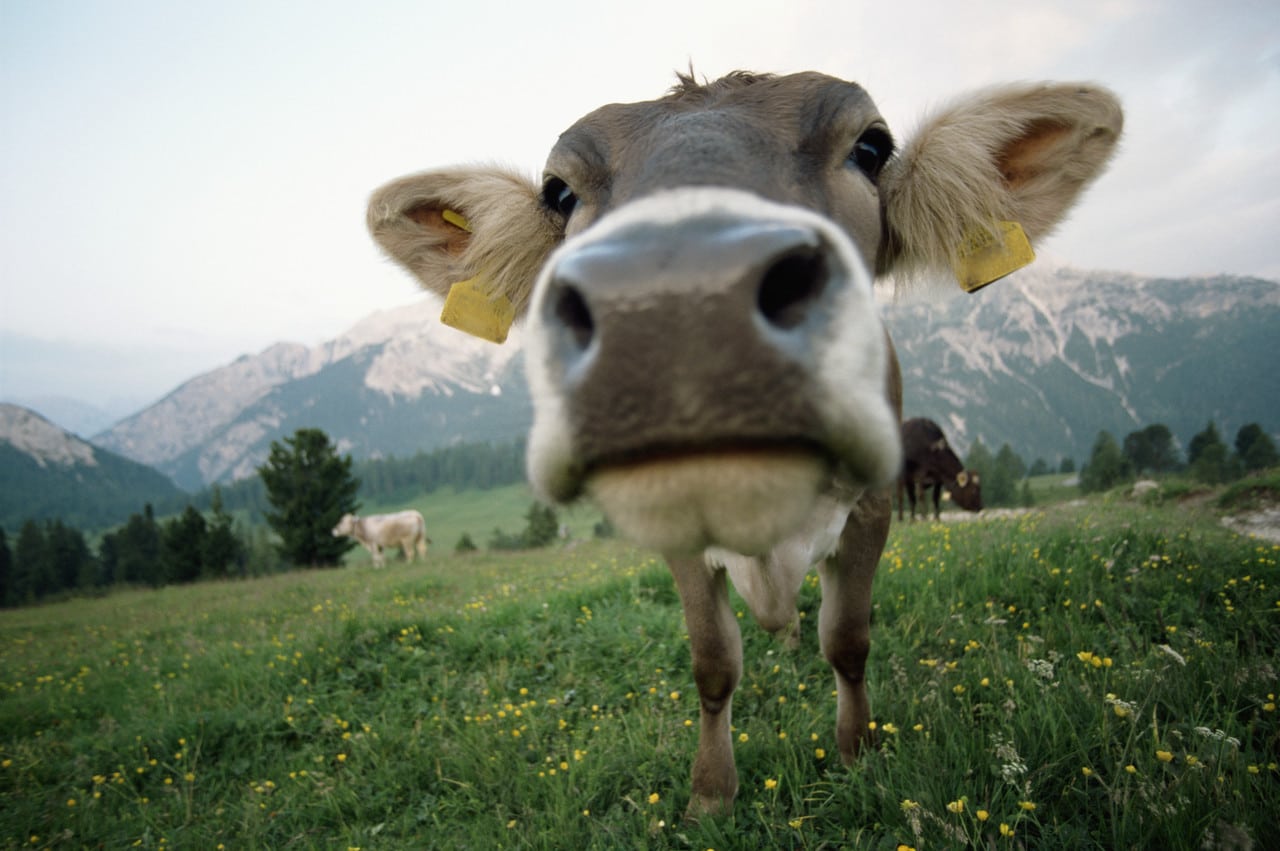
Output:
(886, 264), (1280, 465)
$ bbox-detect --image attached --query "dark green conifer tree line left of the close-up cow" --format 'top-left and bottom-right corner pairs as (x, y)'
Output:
(0, 429), (537, 607)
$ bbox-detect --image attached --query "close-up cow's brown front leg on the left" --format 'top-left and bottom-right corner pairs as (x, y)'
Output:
(667, 555), (742, 819)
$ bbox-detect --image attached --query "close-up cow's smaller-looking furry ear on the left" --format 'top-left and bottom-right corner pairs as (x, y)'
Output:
(369, 168), (563, 316)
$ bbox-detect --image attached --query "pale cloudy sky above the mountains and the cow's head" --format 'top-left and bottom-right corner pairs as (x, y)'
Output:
(0, 0), (1280, 415)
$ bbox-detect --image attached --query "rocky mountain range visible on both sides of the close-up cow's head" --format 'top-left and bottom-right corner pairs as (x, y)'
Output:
(0, 261), (1280, 514)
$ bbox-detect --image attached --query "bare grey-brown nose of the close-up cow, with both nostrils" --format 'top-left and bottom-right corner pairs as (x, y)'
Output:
(536, 215), (852, 459)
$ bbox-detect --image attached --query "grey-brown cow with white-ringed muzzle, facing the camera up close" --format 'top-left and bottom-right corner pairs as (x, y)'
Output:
(367, 72), (1123, 819)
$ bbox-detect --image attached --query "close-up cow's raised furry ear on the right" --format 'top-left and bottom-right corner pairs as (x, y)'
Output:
(877, 83), (1124, 286)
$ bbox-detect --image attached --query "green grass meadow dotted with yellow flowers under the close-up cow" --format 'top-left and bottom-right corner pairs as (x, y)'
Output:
(0, 495), (1280, 851)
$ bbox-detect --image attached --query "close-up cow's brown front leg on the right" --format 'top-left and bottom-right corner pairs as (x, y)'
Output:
(818, 494), (892, 763)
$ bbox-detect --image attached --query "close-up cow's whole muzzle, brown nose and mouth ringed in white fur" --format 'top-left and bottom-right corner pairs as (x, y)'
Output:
(529, 191), (896, 555)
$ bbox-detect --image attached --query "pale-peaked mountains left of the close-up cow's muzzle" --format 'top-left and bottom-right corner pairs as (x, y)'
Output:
(93, 299), (532, 490)
